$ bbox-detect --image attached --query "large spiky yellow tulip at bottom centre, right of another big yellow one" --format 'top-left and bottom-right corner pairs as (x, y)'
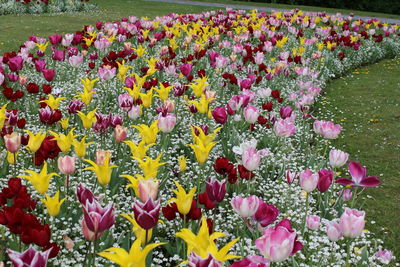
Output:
(176, 217), (240, 262)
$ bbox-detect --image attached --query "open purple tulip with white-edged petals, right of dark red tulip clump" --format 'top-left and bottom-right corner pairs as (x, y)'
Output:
(82, 199), (115, 239)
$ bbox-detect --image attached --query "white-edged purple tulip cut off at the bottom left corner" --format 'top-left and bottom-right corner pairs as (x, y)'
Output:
(7, 246), (52, 267)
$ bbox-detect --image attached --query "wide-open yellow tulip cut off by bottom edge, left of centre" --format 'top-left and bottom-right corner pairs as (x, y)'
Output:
(97, 239), (165, 267)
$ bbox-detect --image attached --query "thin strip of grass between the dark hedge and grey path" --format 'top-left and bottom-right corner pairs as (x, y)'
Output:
(177, 0), (400, 19)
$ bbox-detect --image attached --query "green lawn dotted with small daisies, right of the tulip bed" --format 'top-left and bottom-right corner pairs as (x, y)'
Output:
(316, 59), (400, 258)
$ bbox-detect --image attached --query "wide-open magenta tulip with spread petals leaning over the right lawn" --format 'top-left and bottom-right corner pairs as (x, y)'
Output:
(336, 161), (381, 187)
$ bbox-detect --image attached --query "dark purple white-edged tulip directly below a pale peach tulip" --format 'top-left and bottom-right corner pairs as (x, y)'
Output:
(133, 198), (161, 230)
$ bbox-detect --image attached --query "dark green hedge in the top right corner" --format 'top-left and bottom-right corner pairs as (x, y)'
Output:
(247, 0), (400, 14)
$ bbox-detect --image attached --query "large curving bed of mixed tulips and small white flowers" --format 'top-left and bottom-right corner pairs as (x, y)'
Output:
(0, 7), (400, 266)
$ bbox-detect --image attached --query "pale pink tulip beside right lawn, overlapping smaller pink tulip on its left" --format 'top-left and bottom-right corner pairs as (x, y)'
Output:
(339, 208), (365, 238)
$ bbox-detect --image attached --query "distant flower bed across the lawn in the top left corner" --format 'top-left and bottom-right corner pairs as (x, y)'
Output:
(0, 0), (96, 15)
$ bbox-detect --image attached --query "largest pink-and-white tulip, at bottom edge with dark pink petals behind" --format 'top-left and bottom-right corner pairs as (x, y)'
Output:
(255, 219), (303, 262)
